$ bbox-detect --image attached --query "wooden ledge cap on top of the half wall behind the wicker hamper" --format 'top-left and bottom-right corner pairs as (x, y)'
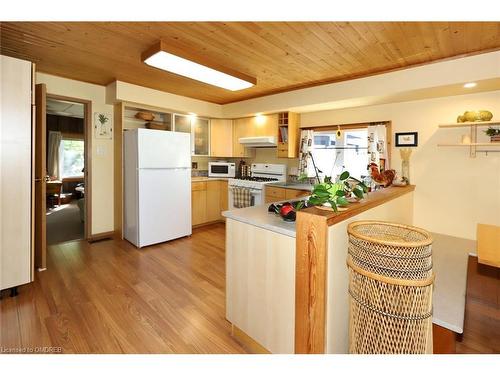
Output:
(303, 185), (415, 226)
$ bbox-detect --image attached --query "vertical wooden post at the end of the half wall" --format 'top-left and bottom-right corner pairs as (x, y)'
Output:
(295, 211), (328, 354)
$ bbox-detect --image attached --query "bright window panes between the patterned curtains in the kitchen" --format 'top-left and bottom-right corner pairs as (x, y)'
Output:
(312, 128), (368, 179)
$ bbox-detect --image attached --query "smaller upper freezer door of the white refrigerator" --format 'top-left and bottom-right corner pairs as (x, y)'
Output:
(137, 129), (191, 168)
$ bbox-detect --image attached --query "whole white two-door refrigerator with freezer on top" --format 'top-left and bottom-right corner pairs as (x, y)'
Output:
(123, 129), (191, 248)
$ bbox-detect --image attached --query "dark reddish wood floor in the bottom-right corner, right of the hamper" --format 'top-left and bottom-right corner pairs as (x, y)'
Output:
(456, 256), (500, 354)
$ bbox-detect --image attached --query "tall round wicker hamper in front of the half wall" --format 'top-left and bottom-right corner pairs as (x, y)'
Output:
(347, 221), (434, 354)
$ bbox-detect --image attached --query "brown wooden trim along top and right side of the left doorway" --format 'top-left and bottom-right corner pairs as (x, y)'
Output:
(46, 92), (92, 240)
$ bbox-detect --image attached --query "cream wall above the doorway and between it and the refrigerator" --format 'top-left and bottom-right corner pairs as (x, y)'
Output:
(36, 73), (114, 234)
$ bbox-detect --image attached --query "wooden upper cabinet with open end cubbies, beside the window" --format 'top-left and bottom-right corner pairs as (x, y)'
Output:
(278, 112), (300, 158)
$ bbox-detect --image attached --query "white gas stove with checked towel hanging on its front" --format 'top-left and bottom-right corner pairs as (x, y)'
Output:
(228, 163), (286, 209)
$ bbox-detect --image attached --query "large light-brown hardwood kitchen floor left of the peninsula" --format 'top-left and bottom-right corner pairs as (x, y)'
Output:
(0, 224), (246, 353)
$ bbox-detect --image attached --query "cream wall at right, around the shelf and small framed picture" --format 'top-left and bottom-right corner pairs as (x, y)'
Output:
(301, 91), (500, 239)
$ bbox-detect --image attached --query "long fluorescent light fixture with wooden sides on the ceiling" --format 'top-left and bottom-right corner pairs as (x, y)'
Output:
(143, 42), (256, 91)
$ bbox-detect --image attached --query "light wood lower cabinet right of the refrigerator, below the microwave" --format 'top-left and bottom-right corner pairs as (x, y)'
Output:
(191, 180), (228, 226)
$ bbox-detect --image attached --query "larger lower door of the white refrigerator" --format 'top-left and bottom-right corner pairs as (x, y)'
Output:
(138, 168), (191, 247)
